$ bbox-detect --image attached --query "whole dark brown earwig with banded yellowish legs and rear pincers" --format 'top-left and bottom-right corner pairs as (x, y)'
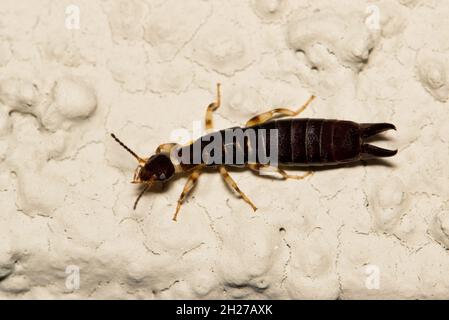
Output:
(111, 84), (397, 221)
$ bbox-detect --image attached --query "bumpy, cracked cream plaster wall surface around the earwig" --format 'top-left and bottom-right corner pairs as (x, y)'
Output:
(0, 0), (449, 299)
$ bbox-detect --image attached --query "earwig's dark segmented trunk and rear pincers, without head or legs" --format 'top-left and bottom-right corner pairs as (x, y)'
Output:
(177, 119), (396, 168)
